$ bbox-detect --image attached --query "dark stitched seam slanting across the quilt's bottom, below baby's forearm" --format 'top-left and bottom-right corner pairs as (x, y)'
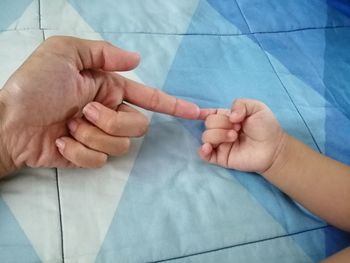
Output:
(147, 225), (329, 263)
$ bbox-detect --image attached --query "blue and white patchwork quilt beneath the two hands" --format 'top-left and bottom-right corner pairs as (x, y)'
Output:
(0, 0), (350, 263)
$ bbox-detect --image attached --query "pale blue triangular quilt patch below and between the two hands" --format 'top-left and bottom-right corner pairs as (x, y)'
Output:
(96, 115), (307, 262)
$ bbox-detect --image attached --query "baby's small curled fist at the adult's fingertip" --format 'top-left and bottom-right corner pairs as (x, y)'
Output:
(199, 99), (285, 174)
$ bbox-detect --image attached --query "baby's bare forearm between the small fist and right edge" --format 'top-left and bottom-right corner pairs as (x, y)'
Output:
(263, 135), (350, 231)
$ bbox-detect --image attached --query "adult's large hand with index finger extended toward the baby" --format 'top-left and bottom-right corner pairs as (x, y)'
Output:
(0, 37), (204, 175)
